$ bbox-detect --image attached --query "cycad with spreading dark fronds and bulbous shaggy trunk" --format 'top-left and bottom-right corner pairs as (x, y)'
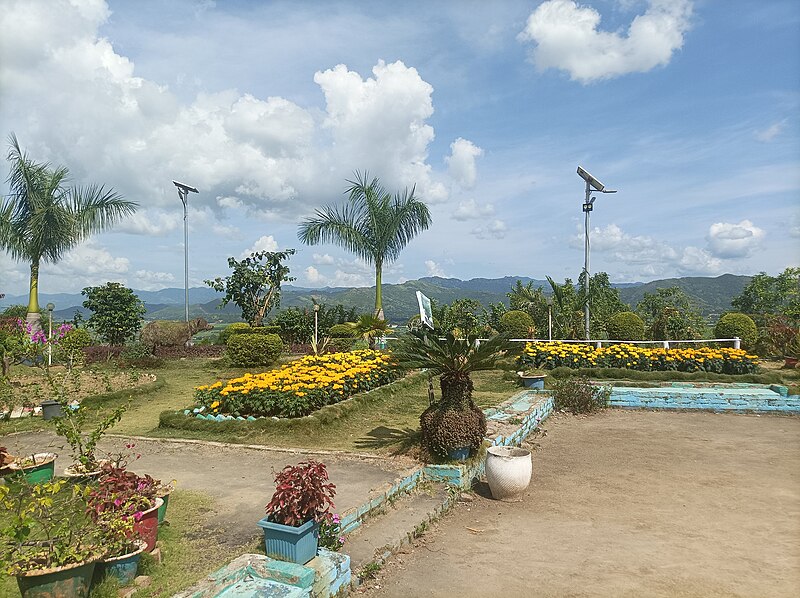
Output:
(394, 330), (508, 459)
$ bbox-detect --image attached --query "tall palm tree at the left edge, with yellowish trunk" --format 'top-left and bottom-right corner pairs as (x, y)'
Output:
(0, 133), (137, 329)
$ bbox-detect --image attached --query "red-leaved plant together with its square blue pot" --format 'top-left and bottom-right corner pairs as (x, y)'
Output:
(258, 459), (336, 565)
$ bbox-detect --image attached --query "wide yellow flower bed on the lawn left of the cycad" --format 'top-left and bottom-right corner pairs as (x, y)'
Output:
(195, 350), (401, 417)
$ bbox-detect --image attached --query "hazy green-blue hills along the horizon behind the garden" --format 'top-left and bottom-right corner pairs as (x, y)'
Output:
(0, 274), (750, 323)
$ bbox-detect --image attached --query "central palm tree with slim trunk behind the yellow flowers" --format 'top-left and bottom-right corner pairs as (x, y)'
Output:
(297, 172), (431, 320)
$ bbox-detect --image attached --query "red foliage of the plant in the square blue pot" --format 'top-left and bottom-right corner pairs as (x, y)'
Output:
(265, 459), (336, 527)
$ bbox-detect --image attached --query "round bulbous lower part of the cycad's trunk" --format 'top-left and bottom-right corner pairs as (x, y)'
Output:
(419, 405), (486, 458)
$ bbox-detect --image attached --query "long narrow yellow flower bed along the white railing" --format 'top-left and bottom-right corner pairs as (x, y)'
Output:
(519, 342), (758, 374)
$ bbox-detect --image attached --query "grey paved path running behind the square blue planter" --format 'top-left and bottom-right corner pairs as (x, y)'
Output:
(0, 432), (406, 545)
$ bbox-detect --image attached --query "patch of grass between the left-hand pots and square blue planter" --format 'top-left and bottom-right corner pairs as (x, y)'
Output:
(0, 490), (255, 598)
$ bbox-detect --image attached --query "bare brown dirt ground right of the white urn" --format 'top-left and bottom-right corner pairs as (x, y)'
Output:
(359, 410), (800, 597)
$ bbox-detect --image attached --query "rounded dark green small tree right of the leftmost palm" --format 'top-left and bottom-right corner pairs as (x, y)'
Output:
(81, 282), (147, 345)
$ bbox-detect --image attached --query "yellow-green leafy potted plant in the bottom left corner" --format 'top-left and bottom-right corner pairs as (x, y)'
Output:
(0, 479), (103, 598)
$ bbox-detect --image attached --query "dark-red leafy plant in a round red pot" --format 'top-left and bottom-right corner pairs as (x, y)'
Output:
(89, 462), (163, 552)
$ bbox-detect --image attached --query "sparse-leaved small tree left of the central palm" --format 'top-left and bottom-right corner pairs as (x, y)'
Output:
(205, 249), (295, 326)
